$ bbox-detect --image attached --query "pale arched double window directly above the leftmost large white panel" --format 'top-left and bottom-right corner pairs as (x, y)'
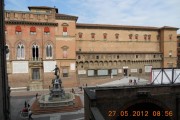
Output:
(17, 43), (25, 59)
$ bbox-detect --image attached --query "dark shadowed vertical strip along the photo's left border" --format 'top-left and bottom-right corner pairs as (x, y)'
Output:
(0, 0), (10, 120)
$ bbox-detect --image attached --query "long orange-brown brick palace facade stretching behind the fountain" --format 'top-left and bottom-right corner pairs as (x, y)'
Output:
(5, 6), (178, 90)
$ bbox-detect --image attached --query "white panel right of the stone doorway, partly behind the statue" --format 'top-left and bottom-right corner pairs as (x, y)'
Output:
(43, 61), (56, 72)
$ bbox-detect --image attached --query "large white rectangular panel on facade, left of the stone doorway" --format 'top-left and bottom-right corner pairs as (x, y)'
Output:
(12, 61), (29, 73)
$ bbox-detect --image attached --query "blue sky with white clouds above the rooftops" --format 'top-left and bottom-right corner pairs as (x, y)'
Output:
(4, 0), (180, 34)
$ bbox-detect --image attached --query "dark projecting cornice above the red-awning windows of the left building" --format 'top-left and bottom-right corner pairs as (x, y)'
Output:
(5, 20), (58, 26)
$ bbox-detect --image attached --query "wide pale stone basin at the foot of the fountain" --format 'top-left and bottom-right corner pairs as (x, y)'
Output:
(39, 93), (75, 108)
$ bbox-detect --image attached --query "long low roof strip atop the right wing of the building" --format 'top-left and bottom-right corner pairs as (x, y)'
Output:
(76, 23), (179, 30)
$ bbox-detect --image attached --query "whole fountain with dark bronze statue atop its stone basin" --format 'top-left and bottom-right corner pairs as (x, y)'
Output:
(39, 65), (75, 107)
